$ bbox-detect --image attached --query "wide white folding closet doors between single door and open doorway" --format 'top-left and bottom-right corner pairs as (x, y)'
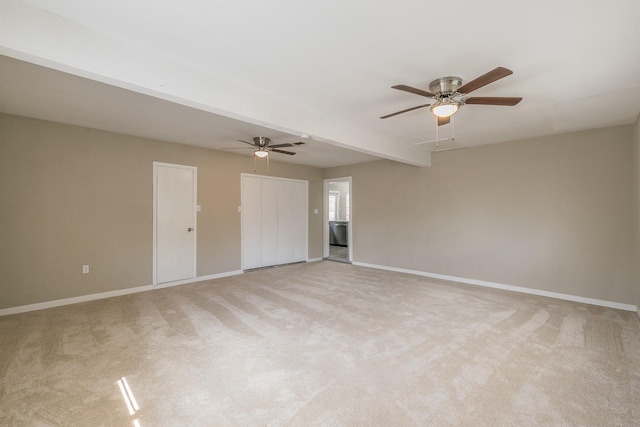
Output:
(242, 175), (308, 270)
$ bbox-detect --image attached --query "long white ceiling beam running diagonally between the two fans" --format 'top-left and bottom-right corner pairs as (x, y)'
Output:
(0, 0), (431, 166)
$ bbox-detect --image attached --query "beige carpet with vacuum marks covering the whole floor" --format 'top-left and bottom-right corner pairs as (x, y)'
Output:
(0, 261), (640, 427)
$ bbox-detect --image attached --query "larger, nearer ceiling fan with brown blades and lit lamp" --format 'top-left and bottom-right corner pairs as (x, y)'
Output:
(380, 67), (522, 126)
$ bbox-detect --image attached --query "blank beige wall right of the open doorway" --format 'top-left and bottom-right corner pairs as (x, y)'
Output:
(325, 126), (638, 304)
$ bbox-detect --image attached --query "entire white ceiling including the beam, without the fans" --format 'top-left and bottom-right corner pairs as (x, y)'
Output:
(0, 0), (640, 167)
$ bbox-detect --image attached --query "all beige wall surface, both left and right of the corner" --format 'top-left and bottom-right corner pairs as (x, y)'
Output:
(0, 114), (640, 308)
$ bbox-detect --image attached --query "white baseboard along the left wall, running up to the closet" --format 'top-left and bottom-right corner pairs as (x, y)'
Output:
(0, 270), (243, 316)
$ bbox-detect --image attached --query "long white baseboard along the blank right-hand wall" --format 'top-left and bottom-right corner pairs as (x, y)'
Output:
(352, 262), (640, 316)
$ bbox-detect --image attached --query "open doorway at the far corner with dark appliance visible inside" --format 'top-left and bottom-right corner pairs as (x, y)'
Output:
(323, 176), (353, 263)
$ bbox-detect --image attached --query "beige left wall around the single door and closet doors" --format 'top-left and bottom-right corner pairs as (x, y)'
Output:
(0, 114), (323, 308)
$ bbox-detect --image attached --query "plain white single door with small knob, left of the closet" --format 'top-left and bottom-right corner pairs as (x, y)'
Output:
(154, 163), (197, 284)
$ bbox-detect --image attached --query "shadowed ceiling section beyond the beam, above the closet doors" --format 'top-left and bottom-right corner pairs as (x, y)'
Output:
(0, 56), (377, 168)
